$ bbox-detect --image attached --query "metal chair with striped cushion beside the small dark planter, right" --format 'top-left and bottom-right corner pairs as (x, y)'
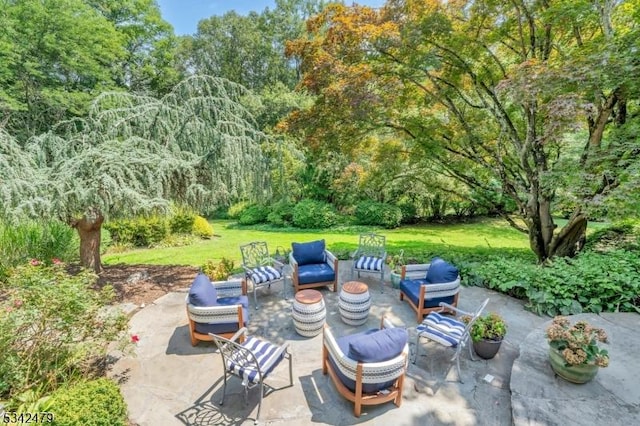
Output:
(413, 298), (489, 383)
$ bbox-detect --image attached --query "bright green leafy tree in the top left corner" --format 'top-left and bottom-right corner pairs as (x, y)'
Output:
(0, 0), (124, 141)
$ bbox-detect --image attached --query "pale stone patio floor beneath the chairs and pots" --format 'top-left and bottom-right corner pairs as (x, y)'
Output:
(110, 262), (640, 426)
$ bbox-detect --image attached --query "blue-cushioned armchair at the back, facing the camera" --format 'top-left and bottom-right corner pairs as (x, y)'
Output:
(289, 240), (338, 293)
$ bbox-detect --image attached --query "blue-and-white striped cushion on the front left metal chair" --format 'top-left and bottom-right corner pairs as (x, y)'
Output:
(227, 337), (284, 386)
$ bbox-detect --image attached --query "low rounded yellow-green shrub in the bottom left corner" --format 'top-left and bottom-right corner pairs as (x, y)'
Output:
(49, 378), (128, 426)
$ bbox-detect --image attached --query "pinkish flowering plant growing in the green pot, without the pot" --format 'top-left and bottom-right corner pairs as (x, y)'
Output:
(547, 316), (609, 367)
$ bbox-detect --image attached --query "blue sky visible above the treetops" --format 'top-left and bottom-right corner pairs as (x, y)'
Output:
(157, 0), (385, 35)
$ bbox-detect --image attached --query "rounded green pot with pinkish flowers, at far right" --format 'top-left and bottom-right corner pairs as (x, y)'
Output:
(546, 316), (609, 383)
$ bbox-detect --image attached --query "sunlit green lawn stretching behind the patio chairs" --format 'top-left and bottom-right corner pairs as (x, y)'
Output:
(102, 219), (599, 267)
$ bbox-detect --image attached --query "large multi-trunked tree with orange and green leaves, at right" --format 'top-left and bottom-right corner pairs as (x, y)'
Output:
(289, 0), (638, 262)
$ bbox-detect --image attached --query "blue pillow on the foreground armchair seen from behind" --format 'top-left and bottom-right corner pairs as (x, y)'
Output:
(348, 328), (408, 362)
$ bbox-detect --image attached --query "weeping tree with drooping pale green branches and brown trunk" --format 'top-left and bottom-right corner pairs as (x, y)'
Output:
(0, 76), (267, 272)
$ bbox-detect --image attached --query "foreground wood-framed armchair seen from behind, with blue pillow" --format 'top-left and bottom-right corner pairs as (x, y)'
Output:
(322, 317), (409, 417)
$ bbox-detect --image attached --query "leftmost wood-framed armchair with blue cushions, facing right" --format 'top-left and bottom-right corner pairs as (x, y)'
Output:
(186, 273), (249, 346)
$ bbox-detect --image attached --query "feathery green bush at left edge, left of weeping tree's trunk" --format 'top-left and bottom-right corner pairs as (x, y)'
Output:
(0, 220), (79, 268)
